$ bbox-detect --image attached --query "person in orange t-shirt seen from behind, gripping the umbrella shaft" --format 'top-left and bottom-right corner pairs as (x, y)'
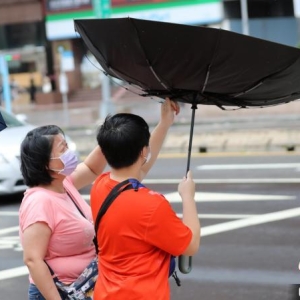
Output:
(91, 99), (200, 300)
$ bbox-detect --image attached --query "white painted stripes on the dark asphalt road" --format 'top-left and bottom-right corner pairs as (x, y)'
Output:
(0, 179), (300, 281)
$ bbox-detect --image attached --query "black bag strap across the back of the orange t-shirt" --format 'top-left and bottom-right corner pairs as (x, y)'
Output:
(94, 179), (144, 253)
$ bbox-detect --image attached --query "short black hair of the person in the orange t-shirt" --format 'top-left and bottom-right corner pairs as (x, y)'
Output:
(97, 113), (150, 169)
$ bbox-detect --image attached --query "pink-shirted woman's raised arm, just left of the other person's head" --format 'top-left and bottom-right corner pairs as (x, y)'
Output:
(71, 146), (106, 190)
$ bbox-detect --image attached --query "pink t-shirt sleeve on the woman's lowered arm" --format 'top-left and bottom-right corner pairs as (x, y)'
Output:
(20, 193), (55, 231)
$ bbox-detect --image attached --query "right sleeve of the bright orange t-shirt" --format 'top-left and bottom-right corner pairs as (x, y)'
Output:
(145, 198), (192, 256)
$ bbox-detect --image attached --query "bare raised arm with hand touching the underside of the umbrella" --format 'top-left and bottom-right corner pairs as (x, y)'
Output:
(142, 98), (180, 179)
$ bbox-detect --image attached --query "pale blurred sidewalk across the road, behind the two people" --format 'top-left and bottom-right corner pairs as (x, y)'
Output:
(10, 96), (300, 155)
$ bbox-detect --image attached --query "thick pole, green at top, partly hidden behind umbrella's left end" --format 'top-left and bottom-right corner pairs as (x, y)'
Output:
(93, 0), (112, 120)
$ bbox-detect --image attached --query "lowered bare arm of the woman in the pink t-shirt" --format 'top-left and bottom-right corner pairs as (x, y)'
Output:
(23, 222), (61, 300)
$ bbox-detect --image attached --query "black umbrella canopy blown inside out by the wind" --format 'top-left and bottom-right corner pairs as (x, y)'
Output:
(75, 18), (300, 107)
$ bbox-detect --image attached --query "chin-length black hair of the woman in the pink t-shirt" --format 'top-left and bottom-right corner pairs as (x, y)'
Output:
(21, 125), (64, 187)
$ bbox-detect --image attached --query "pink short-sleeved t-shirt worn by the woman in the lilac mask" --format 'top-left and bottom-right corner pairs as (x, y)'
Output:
(19, 177), (96, 283)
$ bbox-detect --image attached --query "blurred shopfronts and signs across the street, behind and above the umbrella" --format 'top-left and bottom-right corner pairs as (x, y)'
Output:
(0, 0), (300, 112)
